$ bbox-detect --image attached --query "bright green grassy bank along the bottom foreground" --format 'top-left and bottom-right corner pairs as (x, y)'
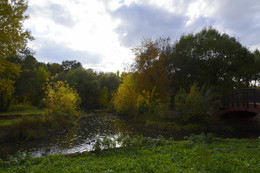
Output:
(0, 135), (260, 173)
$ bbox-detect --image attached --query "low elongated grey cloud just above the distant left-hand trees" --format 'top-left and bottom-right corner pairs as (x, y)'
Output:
(34, 38), (101, 64)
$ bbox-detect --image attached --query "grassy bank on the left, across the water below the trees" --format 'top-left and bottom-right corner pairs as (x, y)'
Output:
(0, 105), (79, 142)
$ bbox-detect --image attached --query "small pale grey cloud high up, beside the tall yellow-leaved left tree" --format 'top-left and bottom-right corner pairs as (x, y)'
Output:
(28, 3), (76, 27)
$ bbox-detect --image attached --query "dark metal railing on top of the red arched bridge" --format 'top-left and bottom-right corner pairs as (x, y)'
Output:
(222, 88), (260, 108)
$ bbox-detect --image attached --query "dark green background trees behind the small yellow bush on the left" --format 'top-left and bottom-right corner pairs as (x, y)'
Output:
(1, 54), (120, 111)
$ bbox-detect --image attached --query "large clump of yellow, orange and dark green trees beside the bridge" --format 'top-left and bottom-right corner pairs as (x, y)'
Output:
(113, 27), (260, 125)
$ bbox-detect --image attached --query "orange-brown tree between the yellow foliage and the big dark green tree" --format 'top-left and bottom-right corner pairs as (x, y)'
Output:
(133, 38), (170, 100)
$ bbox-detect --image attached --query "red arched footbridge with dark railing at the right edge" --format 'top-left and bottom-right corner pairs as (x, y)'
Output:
(217, 88), (260, 121)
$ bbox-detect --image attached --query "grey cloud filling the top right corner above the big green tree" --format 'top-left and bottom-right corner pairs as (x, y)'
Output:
(204, 0), (260, 47)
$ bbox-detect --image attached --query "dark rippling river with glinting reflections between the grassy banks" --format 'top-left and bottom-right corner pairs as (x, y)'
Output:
(0, 111), (259, 159)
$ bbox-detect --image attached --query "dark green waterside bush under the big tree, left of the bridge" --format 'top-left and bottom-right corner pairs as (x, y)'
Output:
(174, 83), (217, 124)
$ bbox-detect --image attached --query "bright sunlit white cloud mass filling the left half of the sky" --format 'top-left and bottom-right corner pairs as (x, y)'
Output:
(25, 0), (131, 71)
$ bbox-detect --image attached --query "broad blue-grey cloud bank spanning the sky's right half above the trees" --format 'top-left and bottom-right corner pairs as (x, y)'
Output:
(110, 0), (260, 47)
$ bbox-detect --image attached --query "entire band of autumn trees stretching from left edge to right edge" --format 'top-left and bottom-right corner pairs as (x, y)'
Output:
(0, 0), (260, 132)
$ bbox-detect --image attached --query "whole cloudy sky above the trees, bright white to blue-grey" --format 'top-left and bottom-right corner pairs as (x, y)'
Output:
(24, 0), (260, 72)
